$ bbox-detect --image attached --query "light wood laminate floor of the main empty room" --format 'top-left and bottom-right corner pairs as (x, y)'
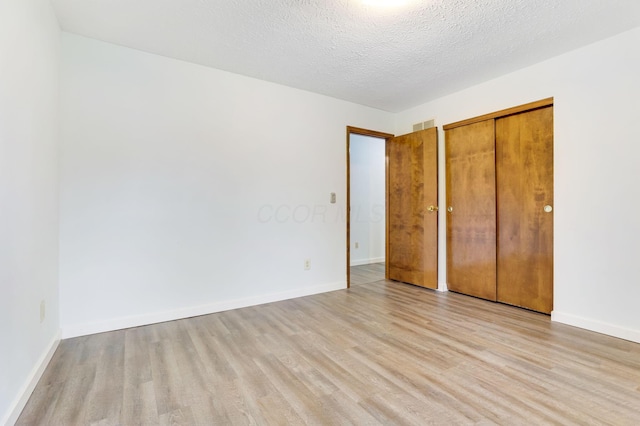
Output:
(17, 268), (640, 425)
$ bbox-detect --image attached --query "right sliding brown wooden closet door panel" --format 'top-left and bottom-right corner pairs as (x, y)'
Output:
(496, 106), (553, 314)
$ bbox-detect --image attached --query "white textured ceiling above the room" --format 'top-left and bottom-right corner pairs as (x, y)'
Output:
(52, 0), (640, 112)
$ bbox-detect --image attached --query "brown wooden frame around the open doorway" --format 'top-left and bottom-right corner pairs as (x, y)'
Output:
(346, 126), (394, 288)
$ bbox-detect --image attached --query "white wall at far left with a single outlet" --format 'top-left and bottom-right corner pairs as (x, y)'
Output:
(0, 0), (60, 424)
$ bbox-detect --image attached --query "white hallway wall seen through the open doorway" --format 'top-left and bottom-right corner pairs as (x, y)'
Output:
(349, 134), (386, 266)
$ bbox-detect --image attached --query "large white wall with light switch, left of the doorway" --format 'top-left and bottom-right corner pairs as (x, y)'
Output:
(60, 34), (393, 336)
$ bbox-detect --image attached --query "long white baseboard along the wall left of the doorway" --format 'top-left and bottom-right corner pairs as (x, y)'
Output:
(62, 281), (347, 339)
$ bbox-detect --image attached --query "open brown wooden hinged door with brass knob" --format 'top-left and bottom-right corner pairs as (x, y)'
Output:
(387, 128), (438, 288)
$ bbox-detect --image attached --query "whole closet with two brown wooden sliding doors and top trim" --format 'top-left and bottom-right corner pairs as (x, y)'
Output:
(444, 98), (553, 314)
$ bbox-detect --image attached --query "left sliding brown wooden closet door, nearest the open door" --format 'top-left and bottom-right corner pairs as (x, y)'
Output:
(445, 119), (496, 301)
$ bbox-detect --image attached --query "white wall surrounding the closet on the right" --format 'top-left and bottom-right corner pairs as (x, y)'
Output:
(396, 28), (640, 342)
